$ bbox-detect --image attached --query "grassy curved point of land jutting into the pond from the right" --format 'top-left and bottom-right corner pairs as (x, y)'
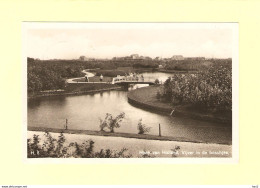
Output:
(128, 86), (232, 124)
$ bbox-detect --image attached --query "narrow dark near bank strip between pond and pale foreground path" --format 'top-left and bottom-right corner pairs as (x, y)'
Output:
(27, 127), (232, 145)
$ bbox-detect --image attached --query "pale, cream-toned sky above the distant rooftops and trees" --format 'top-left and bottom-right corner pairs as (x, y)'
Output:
(26, 23), (233, 60)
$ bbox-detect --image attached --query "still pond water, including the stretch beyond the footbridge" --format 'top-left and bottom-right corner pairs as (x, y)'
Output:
(28, 73), (232, 143)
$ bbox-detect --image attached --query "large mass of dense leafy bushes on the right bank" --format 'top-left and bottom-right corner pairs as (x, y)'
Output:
(163, 62), (232, 111)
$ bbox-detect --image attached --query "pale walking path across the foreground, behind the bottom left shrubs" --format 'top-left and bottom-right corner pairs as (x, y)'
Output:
(27, 131), (232, 157)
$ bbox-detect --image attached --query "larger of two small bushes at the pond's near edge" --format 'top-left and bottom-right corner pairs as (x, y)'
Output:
(99, 112), (125, 133)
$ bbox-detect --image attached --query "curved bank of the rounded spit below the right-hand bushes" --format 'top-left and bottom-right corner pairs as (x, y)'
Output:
(127, 86), (232, 124)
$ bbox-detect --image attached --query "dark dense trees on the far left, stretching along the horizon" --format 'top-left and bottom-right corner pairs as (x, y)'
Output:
(27, 58), (158, 94)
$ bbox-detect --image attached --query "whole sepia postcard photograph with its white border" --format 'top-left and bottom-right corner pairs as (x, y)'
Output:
(22, 22), (238, 160)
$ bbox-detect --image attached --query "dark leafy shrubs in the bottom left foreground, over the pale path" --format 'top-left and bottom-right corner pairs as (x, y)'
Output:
(27, 132), (132, 158)
